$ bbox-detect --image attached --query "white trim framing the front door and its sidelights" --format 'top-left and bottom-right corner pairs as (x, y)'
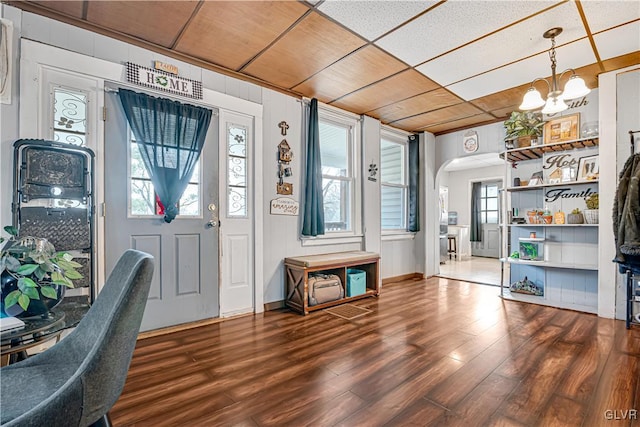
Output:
(19, 39), (264, 313)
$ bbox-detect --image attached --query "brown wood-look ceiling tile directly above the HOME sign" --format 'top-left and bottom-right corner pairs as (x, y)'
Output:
(86, 0), (198, 47)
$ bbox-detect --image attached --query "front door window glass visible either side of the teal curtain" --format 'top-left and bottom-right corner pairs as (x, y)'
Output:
(129, 134), (200, 216)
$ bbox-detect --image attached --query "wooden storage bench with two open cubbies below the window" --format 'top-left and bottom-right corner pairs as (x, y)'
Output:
(284, 251), (380, 315)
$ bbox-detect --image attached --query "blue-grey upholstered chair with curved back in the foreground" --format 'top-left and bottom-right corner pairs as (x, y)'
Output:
(0, 249), (153, 427)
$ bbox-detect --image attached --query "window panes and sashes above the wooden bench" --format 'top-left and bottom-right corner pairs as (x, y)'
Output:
(319, 110), (358, 233)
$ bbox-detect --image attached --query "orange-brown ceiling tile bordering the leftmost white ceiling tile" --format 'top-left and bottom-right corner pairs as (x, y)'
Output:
(243, 12), (366, 88)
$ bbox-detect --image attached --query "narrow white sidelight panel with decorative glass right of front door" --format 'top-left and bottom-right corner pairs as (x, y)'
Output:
(219, 111), (255, 317)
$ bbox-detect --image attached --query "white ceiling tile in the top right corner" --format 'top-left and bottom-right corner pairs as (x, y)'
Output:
(580, 0), (640, 33)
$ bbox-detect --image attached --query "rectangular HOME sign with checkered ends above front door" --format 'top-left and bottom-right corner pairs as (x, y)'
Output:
(127, 62), (202, 99)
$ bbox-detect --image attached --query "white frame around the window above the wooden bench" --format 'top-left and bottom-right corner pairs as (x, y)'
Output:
(301, 104), (363, 246)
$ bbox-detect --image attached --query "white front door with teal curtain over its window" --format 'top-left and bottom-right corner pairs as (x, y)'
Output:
(104, 83), (219, 330)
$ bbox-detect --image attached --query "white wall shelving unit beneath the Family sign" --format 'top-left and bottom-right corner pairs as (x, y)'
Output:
(500, 137), (599, 313)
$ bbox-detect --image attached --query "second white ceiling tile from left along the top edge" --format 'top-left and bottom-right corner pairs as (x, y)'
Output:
(376, 1), (557, 65)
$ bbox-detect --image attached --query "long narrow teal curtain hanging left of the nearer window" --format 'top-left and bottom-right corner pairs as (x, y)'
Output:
(302, 98), (324, 236)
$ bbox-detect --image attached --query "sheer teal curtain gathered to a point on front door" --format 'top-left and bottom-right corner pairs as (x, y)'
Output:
(118, 89), (211, 223)
